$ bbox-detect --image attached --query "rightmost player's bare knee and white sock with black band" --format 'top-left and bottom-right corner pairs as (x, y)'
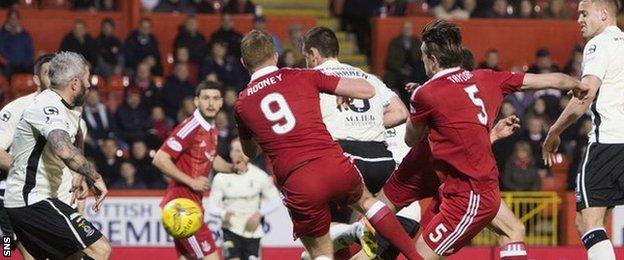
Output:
(576, 207), (615, 260)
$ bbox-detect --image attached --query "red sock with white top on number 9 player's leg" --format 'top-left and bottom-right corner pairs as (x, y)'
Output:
(366, 201), (420, 259)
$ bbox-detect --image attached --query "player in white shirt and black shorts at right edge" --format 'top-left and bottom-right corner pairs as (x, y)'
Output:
(542, 0), (624, 260)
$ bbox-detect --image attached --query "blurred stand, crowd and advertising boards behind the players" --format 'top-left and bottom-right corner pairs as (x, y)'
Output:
(0, 0), (624, 259)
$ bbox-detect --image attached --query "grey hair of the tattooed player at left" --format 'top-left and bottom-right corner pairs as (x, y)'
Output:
(49, 51), (87, 89)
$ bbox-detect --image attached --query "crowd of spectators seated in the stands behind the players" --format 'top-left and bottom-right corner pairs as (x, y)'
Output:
(0, 0), (604, 191)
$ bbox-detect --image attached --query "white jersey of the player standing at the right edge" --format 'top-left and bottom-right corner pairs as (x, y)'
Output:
(582, 26), (624, 144)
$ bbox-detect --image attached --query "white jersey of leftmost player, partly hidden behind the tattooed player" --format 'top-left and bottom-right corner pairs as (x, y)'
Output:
(0, 93), (37, 182)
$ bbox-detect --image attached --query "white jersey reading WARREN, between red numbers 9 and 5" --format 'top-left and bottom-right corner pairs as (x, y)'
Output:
(314, 60), (396, 142)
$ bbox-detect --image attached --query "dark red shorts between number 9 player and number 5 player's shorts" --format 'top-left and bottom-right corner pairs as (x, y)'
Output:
(383, 142), (440, 208)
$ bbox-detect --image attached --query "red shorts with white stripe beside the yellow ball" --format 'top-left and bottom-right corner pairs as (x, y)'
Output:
(174, 223), (217, 259)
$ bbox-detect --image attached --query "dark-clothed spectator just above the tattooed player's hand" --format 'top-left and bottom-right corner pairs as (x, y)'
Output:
(95, 138), (122, 183)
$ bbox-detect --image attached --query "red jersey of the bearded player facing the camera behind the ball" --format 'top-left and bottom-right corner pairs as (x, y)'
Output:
(160, 110), (219, 206)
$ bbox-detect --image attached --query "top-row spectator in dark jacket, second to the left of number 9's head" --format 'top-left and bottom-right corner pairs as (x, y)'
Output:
(173, 15), (208, 64)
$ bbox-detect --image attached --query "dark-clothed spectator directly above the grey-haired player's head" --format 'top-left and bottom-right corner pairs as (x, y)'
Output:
(59, 20), (99, 67)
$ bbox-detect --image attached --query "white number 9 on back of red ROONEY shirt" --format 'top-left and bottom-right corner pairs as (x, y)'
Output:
(260, 93), (296, 135)
